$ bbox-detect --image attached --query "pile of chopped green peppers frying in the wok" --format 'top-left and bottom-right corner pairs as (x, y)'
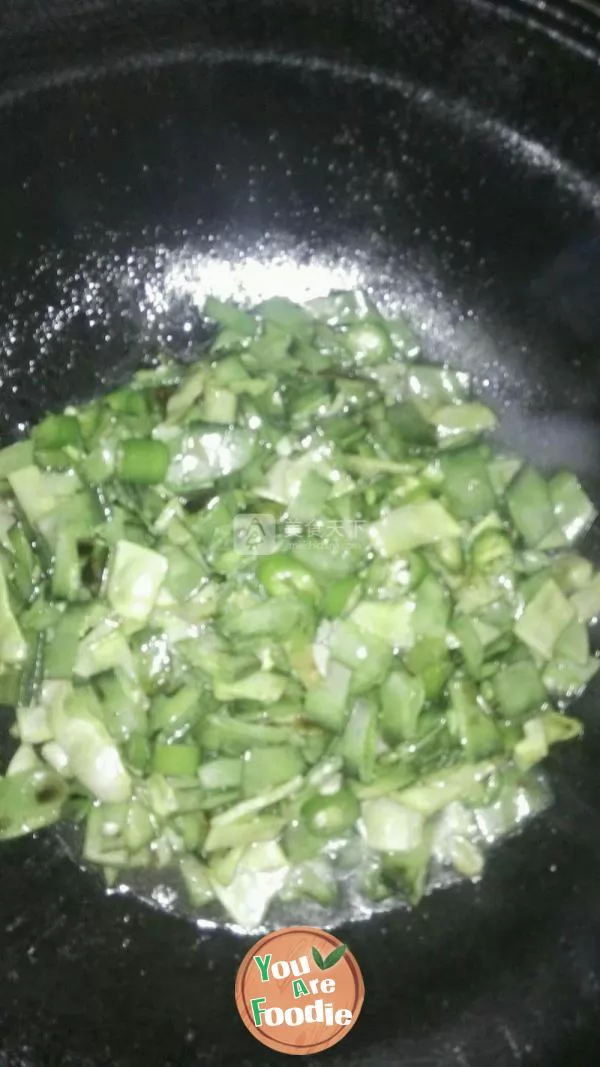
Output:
(0, 293), (600, 927)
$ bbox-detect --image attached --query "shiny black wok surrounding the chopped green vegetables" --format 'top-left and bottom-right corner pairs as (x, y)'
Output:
(0, 0), (600, 1067)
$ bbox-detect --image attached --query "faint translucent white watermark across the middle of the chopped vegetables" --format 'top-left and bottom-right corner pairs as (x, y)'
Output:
(233, 514), (368, 556)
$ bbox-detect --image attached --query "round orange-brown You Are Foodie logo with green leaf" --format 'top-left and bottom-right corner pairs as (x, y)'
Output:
(236, 926), (364, 1056)
